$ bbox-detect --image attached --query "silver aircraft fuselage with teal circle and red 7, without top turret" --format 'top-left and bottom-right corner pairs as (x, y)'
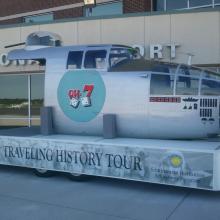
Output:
(9, 45), (220, 139)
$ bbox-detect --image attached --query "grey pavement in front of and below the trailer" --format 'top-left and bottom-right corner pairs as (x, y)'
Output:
(0, 166), (220, 220)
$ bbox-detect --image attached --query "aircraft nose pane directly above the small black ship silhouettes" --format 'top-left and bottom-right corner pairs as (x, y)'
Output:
(176, 76), (199, 95)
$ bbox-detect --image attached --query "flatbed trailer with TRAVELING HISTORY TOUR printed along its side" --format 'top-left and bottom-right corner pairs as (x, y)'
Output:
(0, 127), (220, 191)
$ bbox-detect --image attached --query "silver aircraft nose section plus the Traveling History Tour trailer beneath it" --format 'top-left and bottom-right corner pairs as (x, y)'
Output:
(4, 32), (220, 191)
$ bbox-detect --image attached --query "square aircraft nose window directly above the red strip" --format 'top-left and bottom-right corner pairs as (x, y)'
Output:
(150, 74), (174, 95)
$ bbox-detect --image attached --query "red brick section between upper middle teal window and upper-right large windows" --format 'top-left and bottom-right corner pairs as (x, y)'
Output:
(123, 0), (151, 13)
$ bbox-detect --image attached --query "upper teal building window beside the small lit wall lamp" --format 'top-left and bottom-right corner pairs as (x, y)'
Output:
(84, 1), (123, 17)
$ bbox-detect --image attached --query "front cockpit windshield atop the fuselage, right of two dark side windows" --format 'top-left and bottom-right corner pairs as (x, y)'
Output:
(109, 48), (135, 67)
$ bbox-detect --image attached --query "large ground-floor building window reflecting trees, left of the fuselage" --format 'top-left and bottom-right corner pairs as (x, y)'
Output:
(0, 74), (44, 127)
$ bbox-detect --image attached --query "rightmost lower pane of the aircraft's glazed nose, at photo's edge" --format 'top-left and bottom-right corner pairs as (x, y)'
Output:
(201, 79), (220, 95)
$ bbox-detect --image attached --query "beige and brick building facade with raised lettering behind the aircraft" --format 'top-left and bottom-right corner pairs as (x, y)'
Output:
(0, 0), (220, 126)
